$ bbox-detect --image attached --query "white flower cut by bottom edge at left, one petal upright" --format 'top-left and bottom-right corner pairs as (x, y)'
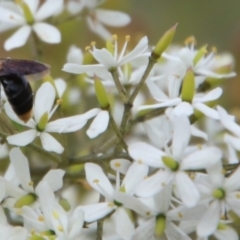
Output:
(21, 181), (84, 240)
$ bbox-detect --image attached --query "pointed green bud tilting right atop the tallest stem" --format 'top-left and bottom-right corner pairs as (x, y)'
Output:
(152, 24), (177, 59)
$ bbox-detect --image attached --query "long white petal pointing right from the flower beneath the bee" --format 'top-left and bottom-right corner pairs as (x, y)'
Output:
(45, 108), (101, 133)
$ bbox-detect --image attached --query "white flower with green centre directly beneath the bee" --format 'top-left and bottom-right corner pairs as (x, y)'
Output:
(4, 82), (99, 153)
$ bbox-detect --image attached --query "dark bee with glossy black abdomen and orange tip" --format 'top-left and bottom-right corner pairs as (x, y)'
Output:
(0, 58), (50, 122)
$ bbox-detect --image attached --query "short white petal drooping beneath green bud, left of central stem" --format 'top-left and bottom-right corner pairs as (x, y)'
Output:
(87, 111), (109, 138)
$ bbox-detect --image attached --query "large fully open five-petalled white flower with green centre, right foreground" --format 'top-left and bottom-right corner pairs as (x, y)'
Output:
(129, 115), (222, 207)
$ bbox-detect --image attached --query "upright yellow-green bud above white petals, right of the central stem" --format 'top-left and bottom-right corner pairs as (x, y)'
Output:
(182, 69), (195, 103)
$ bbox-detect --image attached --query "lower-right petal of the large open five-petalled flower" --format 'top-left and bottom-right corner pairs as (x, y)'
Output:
(175, 172), (200, 208)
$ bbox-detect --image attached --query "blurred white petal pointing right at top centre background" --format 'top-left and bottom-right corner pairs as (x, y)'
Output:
(95, 9), (131, 27)
